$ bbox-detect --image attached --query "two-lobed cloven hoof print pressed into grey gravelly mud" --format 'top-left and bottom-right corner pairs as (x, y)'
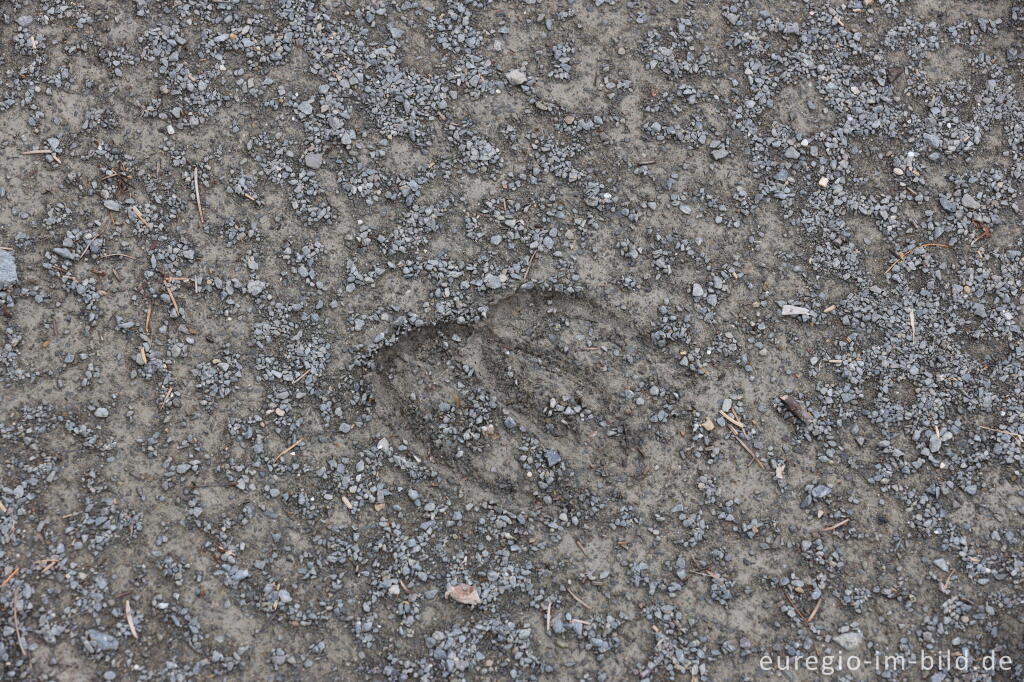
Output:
(377, 292), (688, 499)
